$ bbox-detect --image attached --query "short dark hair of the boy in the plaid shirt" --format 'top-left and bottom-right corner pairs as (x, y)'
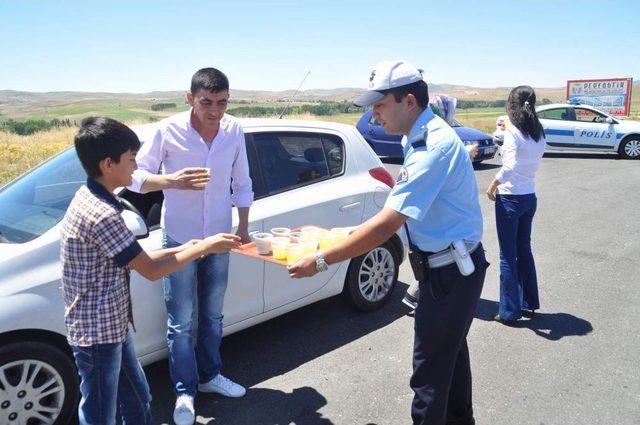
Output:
(74, 117), (140, 178)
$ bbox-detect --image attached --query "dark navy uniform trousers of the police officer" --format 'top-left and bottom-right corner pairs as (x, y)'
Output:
(410, 245), (489, 425)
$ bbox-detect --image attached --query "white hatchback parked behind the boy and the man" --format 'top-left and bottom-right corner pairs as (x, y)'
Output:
(0, 120), (407, 424)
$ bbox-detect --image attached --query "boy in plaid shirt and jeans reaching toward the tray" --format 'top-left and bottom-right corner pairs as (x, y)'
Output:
(61, 118), (240, 425)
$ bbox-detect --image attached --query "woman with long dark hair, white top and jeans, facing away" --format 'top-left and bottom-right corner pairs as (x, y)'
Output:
(487, 86), (545, 322)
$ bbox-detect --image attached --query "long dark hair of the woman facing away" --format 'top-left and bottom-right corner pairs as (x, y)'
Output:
(507, 86), (545, 142)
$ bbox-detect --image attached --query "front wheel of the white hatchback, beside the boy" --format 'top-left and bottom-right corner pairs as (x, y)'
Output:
(0, 342), (79, 424)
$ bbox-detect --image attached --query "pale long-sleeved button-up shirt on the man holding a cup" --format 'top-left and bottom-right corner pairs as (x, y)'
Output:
(129, 110), (253, 243)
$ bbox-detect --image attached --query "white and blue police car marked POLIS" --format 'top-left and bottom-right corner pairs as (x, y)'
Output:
(536, 104), (640, 159)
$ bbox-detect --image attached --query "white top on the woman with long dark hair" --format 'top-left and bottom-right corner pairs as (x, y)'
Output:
(496, 124), (546, 195)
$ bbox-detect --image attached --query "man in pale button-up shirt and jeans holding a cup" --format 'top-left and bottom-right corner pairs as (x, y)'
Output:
(131, 68), (253, 425)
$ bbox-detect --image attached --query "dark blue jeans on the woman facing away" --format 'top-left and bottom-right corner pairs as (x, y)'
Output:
(496, 193), (540, 320)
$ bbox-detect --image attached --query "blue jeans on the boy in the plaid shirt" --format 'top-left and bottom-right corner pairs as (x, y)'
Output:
(72, 335), (154, 425)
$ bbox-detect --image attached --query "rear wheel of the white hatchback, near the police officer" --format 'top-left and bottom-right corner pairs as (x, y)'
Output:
(342, 241), (400, 311)
